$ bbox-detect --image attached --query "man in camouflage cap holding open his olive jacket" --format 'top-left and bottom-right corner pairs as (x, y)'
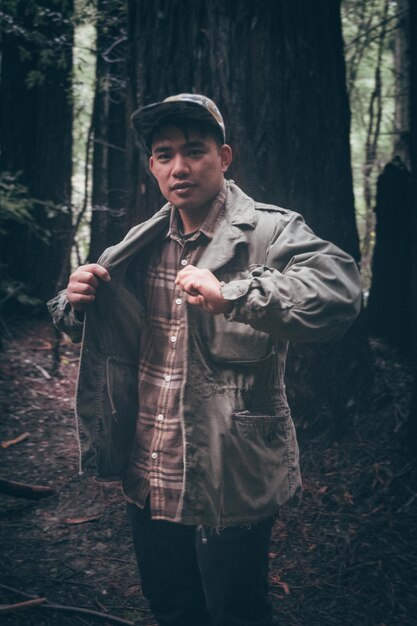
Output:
(50, 94), (360, 626)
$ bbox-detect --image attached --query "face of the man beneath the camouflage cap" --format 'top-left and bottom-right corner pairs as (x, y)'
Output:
(149, 126), (232, 211)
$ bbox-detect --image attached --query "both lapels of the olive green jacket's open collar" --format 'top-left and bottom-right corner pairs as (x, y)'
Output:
(98, 180), (258, 272)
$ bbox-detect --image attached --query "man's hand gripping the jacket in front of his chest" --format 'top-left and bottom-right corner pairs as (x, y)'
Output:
(175, 265), (233, 315)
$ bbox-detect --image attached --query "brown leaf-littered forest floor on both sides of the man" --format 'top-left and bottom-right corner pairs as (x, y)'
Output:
(0, 322), (417, 626)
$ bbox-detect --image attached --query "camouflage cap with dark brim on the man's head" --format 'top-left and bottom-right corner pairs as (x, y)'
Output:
(131, 94), (226, 150)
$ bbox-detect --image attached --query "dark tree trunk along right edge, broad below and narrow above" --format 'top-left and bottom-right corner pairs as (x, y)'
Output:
(366, 0), (413, 352)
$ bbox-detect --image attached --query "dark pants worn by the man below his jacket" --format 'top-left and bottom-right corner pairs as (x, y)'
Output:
(127, 504), (274, 626)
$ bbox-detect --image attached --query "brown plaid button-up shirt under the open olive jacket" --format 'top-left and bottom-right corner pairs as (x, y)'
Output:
(123, 186), (226, 521)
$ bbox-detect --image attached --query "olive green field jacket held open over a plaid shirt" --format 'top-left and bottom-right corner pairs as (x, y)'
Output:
(49, 182), (361, 527)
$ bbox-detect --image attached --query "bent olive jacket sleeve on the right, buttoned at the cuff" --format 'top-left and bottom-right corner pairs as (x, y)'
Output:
(222, 213), (361, 342)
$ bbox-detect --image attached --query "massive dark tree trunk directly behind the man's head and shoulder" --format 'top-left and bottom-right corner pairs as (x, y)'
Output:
(128, 0), (359, 428)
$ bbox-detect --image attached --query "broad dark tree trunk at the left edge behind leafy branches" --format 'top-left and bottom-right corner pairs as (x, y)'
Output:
(0, 0), (73, 299)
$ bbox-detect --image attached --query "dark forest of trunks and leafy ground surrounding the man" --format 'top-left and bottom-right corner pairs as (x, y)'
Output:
(0, 0), (417, 626)
